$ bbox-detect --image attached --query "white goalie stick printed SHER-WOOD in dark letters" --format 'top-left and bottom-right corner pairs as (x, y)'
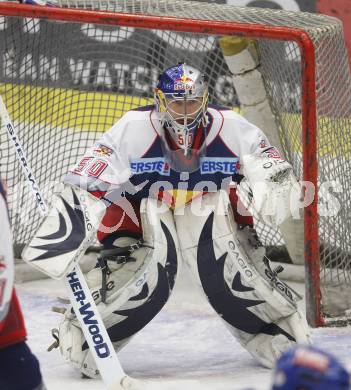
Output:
(0, 96), (133, 390)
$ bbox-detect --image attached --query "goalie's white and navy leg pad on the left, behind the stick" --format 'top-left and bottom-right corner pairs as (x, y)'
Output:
(58, 199), (178, 377)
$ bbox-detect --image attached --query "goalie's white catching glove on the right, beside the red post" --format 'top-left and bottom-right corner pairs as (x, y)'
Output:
(242, 148), (301, 226)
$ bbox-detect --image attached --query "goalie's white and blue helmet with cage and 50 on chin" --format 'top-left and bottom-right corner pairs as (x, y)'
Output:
(155, 63), (208, 155)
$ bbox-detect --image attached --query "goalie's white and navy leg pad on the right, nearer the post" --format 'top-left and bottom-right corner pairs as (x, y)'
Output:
(175, 191), (308, 367)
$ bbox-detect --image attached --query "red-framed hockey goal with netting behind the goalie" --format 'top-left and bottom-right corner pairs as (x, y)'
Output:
(0, 0), (351, 326)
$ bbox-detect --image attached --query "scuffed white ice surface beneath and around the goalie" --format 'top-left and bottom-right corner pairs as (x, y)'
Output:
(17, 266), (351, 390)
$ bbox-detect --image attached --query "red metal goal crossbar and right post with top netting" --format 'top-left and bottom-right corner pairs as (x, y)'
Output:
(0, 0), (350, 326)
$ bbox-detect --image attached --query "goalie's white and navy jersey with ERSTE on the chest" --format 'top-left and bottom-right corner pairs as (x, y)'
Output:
(66, 106), (278, 210)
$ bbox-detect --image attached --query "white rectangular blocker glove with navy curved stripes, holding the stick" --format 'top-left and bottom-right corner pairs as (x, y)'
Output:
(22, 184), (105, 279)
